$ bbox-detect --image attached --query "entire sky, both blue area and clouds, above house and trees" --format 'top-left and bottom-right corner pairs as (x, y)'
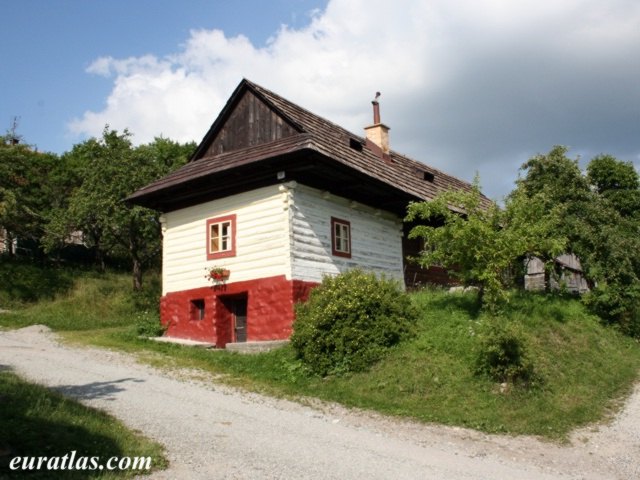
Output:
(0, 0), (640, 198)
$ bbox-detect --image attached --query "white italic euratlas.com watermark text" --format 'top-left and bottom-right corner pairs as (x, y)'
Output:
(9, 450), (151, 471)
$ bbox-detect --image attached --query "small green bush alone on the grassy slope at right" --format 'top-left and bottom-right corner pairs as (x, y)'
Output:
(476, 319), (542, 387)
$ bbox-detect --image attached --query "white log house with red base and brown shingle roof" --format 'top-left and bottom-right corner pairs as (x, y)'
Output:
(128, 80), (482, 348)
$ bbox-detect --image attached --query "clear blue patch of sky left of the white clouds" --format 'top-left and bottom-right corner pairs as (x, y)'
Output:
(0, 0), (325, 153)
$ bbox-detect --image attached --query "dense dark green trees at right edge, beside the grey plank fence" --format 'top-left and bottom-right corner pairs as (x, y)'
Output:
(517, 147), (640, 335)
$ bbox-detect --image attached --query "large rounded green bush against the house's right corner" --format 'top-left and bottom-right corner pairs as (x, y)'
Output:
(291, 270), (417, 375)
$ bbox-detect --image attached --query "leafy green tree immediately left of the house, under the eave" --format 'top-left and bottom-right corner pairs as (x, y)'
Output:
(48, 127), (194, 290)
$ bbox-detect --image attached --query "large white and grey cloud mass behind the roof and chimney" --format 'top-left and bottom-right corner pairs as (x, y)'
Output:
(69, 0), (640, 199)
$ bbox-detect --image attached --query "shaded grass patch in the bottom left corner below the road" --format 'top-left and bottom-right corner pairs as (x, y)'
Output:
(0, 371), (167, 479)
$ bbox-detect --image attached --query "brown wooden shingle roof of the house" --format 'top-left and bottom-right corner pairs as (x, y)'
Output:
(127, 79), (488, 211)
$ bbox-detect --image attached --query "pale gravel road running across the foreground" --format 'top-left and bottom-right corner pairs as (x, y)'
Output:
(0, 326), (640, 480)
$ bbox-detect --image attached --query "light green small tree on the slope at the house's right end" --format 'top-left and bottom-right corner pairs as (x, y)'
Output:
(406, 181), (566, 311)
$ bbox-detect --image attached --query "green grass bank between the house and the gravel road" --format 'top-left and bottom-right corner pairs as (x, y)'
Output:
(0, 260), (640, 439)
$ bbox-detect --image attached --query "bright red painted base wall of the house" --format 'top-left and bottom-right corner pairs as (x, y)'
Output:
(160, 275), (317, 348)
